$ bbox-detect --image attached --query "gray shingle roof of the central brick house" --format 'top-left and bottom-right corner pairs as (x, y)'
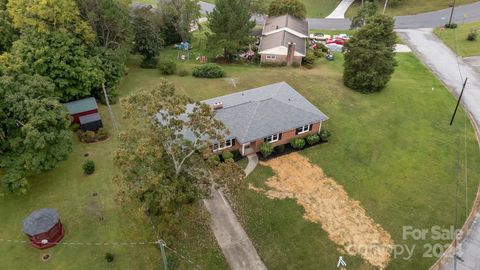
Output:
(203, 82), (328, 143)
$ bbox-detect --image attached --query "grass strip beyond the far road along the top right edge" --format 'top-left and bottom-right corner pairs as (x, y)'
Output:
(345, 0), (476, 18)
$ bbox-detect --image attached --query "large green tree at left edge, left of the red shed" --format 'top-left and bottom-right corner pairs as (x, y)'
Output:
(0, 71), (72, 194)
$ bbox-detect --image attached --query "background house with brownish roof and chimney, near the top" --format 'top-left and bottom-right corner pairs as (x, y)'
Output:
(258, 15), (308, 65)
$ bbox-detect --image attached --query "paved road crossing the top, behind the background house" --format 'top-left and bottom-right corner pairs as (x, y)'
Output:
(200, 0), (480, 30)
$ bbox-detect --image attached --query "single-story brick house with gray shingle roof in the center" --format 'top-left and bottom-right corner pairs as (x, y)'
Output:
(203, 82), (328, 155)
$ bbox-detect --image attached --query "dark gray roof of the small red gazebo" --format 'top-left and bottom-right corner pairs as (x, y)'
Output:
(23, 208), (59, 235)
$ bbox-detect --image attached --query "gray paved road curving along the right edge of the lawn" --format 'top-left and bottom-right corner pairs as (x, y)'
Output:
(398, 29), (480, 270)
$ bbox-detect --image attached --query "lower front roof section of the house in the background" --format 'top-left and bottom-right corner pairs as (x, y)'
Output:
(258, 31), (307, 55)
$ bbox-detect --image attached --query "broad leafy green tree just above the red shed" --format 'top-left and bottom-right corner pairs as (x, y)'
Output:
(12, 29), (104, 102)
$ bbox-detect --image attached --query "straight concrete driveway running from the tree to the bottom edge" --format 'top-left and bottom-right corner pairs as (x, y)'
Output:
(203, 188), (267, 270)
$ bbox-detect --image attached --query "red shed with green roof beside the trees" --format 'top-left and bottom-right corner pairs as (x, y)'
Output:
(63, 97), (103, 131)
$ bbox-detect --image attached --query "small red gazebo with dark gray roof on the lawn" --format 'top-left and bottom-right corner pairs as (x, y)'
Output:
(23, 208), (65, 249)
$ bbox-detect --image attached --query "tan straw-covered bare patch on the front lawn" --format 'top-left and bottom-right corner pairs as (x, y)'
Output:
(255, 153), (394, 269)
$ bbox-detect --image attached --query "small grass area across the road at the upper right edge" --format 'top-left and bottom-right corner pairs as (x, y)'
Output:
(435, 22), (480, 56)
